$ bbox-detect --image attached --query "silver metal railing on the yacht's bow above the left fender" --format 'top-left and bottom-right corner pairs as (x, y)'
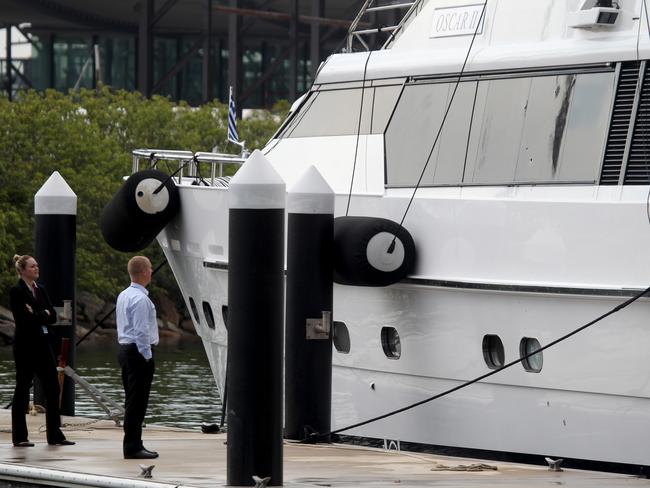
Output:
(132, 149), (248, 186)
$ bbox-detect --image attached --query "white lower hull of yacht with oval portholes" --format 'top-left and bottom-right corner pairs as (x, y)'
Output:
(153, 182), (650, 465)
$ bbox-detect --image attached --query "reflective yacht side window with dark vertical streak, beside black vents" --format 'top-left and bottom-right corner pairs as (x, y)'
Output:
(464, 72), (614, 184)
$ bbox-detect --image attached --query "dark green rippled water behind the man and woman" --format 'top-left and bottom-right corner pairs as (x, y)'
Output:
(0, 344), (221, 429)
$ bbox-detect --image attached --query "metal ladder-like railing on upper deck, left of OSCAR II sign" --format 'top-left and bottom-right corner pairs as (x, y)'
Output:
(346, 0), (423, 52)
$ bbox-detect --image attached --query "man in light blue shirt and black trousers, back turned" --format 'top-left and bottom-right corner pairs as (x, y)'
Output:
(116, 256), (158, 459)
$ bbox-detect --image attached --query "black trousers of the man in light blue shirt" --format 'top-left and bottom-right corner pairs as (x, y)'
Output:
(118, 344), (155, 454)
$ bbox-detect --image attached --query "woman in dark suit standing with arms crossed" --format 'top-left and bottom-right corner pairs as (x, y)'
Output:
(9, 255), (74, 447)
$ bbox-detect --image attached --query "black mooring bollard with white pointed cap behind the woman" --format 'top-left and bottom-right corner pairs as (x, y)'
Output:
(34, 171), (77, 415)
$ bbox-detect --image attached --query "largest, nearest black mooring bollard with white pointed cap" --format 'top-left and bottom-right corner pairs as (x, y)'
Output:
(226, 151), (286, 486)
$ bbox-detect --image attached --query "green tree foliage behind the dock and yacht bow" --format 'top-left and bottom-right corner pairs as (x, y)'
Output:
(0, 88), (287, 305)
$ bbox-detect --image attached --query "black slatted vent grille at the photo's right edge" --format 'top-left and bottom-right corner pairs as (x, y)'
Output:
(623, 63), (650, 185)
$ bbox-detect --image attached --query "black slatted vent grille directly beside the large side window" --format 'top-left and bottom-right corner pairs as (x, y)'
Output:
(600, 61), (636, 185)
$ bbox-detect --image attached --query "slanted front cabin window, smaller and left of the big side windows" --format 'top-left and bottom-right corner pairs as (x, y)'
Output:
(281, 85), (401, 137)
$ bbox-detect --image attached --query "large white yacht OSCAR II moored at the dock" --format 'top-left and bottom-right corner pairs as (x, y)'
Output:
(111, 0), (650, 466)
